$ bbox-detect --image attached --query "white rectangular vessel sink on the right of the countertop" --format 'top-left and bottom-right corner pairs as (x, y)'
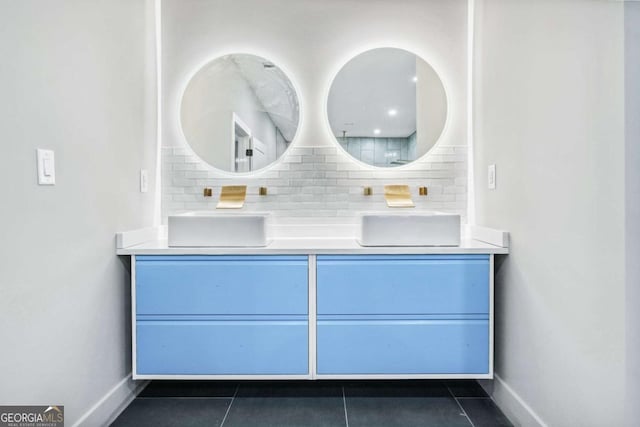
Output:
(358, 212), (460, 246)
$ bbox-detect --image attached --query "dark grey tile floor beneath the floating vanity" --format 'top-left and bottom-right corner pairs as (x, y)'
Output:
(112, 380), (511, 427)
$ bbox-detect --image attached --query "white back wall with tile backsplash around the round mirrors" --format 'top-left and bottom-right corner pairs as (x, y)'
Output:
(162, 0), (467, 221)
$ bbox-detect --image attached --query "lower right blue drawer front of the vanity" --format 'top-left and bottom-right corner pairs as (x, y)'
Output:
(318, 320), (489, 375)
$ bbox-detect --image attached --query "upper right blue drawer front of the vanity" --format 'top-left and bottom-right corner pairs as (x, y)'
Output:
(317, 255), (489, 314)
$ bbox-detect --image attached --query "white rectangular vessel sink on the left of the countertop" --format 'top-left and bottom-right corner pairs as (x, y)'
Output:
(168, 211), (270, 247)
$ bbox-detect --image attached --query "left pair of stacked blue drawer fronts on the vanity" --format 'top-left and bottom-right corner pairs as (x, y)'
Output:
(134, 255), (309, 378)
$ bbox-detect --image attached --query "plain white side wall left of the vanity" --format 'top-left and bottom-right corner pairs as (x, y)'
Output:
(0, 0), (155, 426)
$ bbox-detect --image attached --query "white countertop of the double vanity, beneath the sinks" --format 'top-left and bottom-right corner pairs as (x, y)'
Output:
(117, 237), (509, 255)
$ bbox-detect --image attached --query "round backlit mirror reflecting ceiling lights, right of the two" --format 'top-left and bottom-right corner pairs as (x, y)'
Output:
(327, 48), (447, 167)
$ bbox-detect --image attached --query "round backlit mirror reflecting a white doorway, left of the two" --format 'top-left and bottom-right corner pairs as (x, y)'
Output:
(180, 53), (300, 172)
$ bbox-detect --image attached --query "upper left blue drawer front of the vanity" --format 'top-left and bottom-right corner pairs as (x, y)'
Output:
(136, 256), (309, 314)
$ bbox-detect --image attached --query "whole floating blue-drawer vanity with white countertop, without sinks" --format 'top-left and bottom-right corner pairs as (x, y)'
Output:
(118, 229), (508, 379)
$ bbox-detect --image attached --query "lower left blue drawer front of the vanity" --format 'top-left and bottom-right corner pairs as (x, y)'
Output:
(136, 320), (309, 375)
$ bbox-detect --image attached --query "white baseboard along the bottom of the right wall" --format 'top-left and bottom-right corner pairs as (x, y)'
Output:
(479, 374), (548, 427)
